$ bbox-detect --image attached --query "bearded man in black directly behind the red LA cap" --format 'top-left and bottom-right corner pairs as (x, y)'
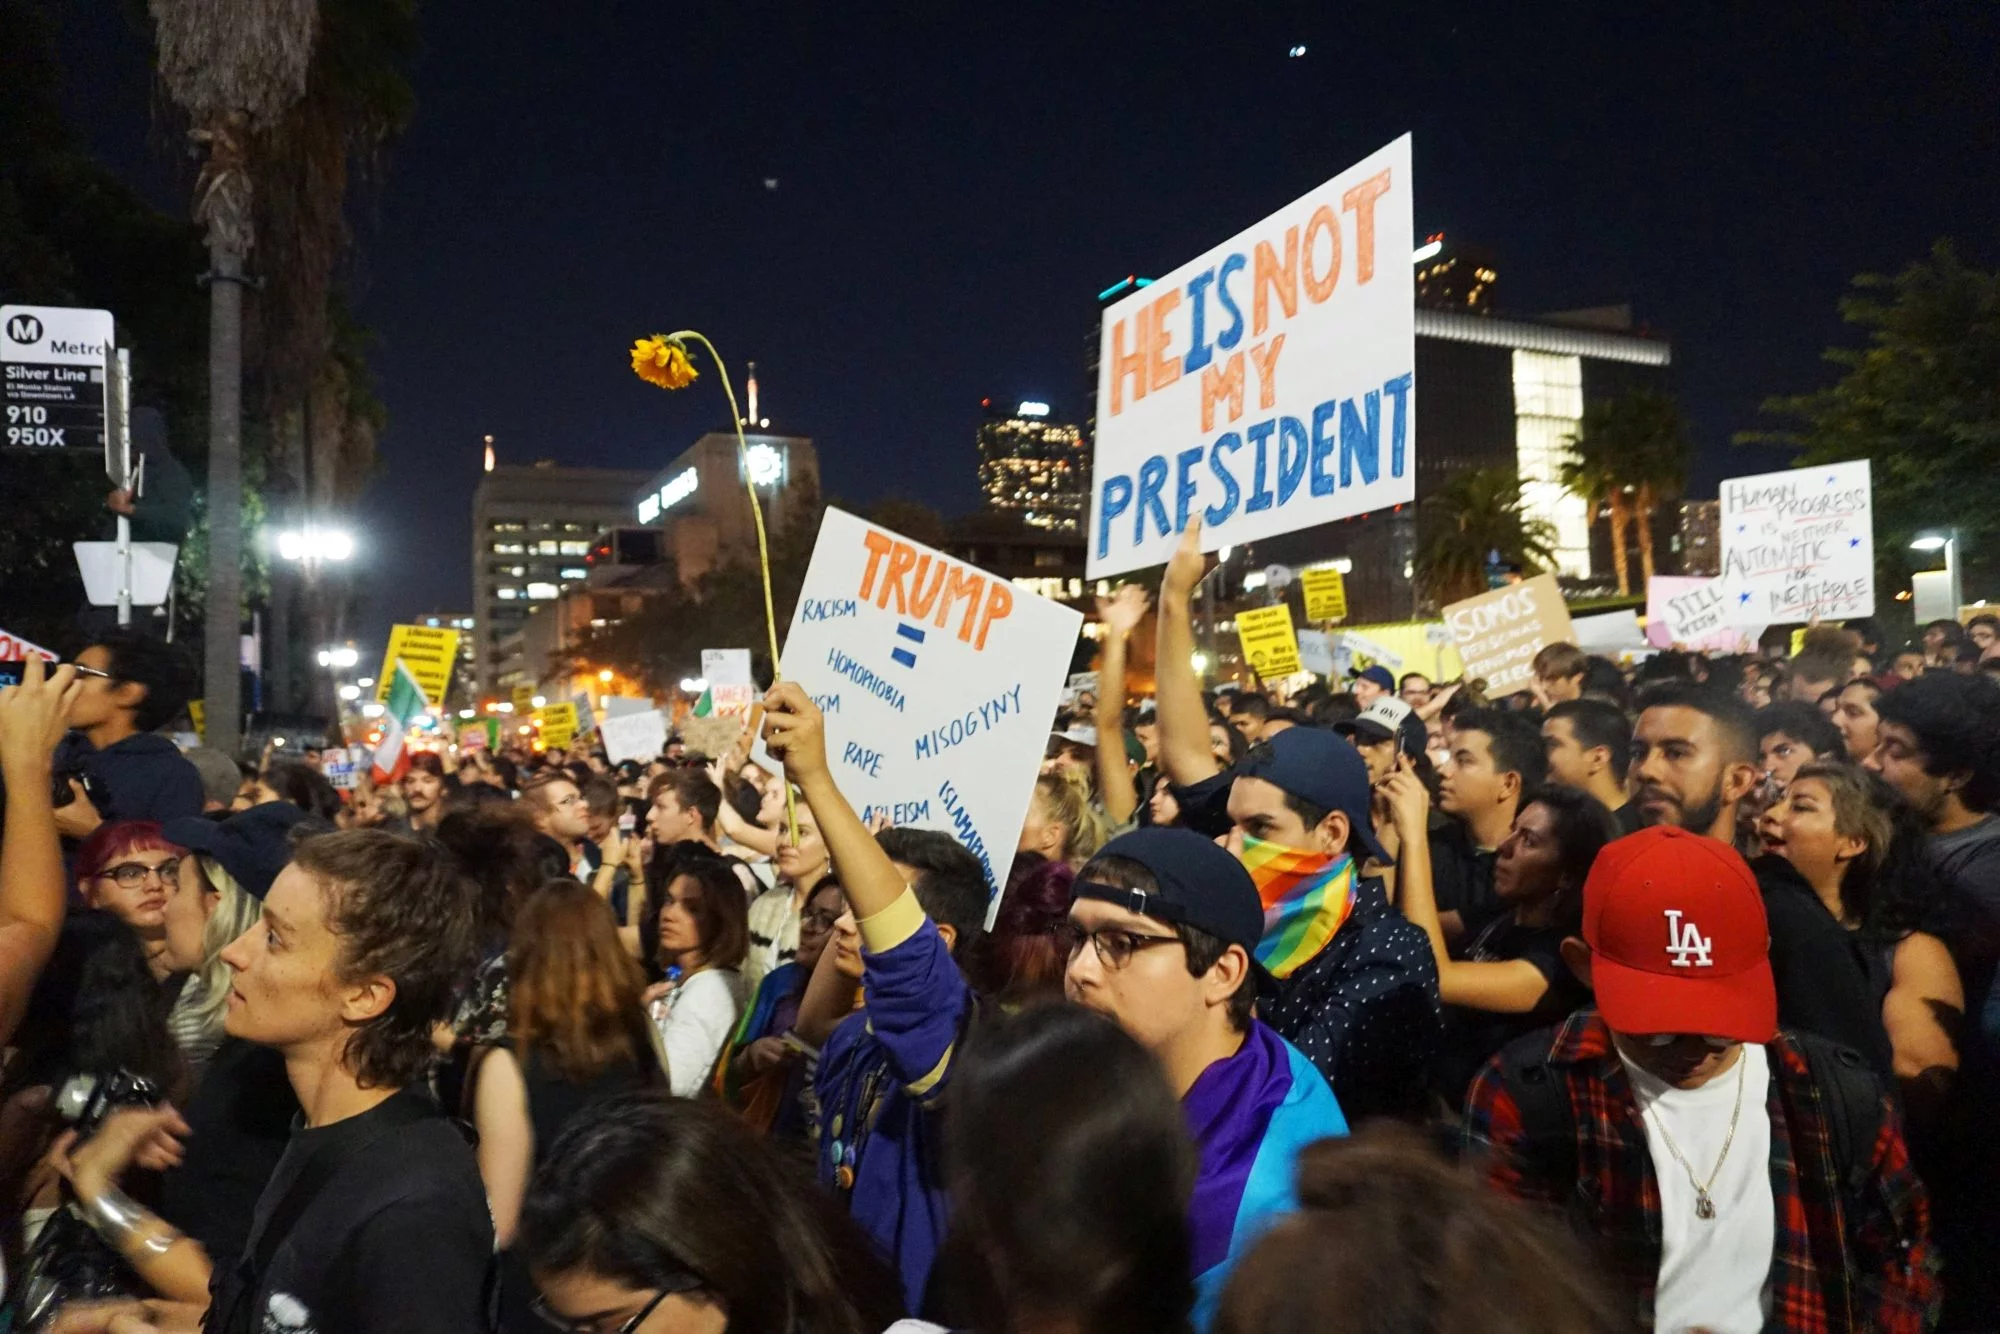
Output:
(1626, 684), (1892, 1074)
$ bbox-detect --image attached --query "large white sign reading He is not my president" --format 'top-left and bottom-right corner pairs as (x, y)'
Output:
(1086, 134), (1416, 578)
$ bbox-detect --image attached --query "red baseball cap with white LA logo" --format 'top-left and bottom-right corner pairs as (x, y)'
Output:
(1584, 824), (1778, 1044)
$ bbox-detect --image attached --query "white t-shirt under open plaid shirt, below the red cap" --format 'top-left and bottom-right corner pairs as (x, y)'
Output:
(1618, 1042), (1778, 1334)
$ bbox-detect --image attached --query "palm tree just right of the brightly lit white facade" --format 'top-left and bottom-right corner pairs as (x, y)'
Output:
(1556, 390), (1692, 596)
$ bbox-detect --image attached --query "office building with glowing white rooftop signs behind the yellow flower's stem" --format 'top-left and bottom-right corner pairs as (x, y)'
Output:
(618, 430), (820, 584)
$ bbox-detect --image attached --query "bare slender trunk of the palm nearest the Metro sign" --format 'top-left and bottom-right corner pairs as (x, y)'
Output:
(202, 228), (244, 756)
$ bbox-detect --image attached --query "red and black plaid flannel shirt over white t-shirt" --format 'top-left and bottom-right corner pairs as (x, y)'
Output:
(1466, 1010), (1938, 1334)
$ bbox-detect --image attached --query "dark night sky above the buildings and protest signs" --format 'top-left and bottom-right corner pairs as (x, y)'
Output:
(58, 0), (2000, 648)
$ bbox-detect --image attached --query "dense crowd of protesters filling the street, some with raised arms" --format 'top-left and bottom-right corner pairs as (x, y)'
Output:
(0, 576), (2000, 1334)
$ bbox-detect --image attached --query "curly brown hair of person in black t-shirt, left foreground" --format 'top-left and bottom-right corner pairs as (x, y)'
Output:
(292, 830), (478, 1088)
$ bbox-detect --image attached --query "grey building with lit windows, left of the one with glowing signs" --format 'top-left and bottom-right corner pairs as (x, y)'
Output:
(472, 462), (648, 694)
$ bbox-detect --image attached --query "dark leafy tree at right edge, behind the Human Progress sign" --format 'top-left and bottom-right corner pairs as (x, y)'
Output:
(1738, 240), (2000, 584)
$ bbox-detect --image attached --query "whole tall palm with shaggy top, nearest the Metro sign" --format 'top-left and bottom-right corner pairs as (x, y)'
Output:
(148, 0), (320, 754)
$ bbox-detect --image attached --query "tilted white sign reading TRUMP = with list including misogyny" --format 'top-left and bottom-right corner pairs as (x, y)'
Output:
(784, 508), (1084, 908)
